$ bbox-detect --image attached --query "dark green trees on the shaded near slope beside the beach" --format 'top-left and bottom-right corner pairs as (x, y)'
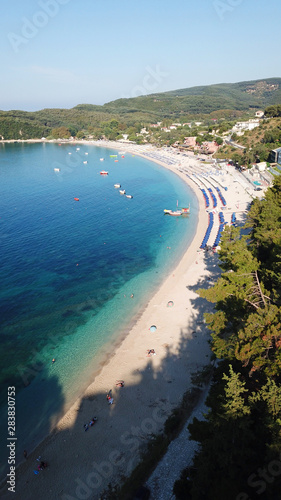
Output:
(174, 177), (281, 500)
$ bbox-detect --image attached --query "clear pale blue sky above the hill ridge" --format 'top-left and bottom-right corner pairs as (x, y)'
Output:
(0, 0), (281, 111)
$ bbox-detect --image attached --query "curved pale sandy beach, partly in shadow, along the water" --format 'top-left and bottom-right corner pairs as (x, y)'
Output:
(1, 141), (262, 500)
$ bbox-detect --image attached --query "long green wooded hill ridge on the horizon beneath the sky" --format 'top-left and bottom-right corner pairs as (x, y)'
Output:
(0, 78), (281, 139)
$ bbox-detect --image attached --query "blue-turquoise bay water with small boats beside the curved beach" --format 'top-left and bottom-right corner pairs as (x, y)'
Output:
(0, 144), (198, 472)
